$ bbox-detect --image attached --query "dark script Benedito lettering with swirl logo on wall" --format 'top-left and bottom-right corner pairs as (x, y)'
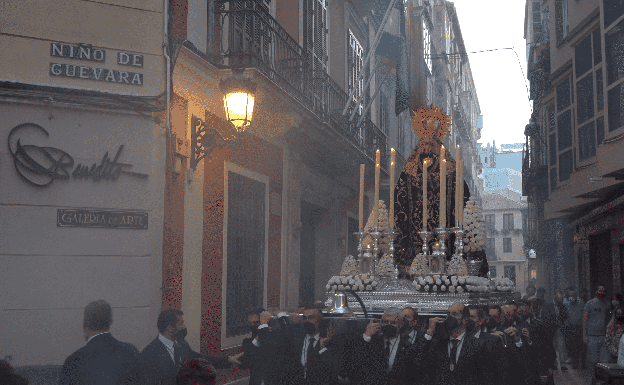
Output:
(8, 123), (148, 187)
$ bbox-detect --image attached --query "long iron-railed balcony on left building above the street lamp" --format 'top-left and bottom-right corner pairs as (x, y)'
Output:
(207, 0), (389, 164)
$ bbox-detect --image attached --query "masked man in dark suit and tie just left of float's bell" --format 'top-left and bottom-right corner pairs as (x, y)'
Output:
(270, 306), (337, 385)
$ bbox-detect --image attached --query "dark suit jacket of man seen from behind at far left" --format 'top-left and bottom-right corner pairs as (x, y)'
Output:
(60, 333), (139, 385)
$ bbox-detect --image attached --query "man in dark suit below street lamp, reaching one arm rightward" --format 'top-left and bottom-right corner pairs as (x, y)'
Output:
(139, 310), (231, 385)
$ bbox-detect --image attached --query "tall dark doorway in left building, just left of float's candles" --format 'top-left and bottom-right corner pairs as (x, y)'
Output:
(299, 201), (326, 304)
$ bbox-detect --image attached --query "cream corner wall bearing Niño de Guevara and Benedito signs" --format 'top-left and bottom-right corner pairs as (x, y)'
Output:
(0, 0), (168, 366)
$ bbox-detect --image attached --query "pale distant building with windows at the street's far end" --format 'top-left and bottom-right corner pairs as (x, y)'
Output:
(481, 188), (534, 293)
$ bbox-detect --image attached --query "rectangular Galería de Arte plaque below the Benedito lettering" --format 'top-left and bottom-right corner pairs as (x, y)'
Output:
(56, 209), (148, 230)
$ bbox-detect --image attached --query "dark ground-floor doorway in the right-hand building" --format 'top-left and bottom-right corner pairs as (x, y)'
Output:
(589, 231), (613, 295)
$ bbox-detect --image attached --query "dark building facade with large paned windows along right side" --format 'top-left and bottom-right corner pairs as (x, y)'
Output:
(523, 0), (624, 293)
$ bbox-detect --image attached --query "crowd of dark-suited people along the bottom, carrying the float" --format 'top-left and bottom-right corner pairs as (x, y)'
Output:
(0, 286), (624, 385)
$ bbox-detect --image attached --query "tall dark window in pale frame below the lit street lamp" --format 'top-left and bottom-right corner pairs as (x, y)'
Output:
(225, 170), (267, 338)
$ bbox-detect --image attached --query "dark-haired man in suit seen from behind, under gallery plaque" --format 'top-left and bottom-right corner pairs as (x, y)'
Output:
(60, 300), (139, 385)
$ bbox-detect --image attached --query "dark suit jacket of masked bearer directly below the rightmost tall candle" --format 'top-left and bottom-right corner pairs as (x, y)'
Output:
(431, 333), (487, 385)
